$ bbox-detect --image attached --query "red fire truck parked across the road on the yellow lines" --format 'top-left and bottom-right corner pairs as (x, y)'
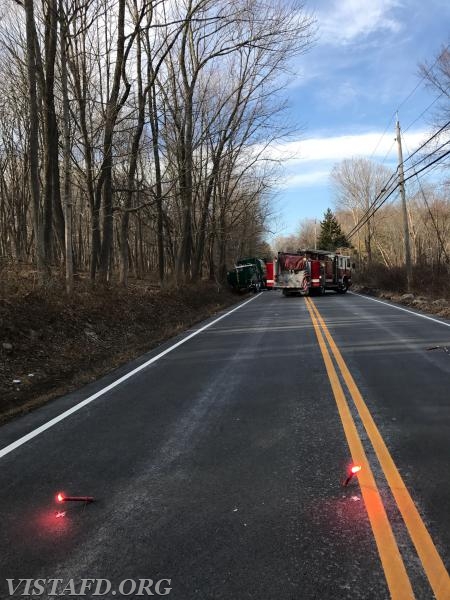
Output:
(274, 250), (352, 296)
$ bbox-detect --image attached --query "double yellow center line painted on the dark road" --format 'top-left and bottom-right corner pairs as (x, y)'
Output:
(306, 298), (450, 600)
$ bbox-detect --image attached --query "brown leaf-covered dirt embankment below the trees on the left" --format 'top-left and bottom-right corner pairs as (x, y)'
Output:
(0, 283), (241, 422)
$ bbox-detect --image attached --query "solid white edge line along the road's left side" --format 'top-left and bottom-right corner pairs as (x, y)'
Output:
(0, 294), (260, 458)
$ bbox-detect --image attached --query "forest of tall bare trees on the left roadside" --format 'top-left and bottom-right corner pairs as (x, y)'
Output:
(0, 0), (312, 293)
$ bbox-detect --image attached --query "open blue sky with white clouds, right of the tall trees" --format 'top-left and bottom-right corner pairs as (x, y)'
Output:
(270, 0), (450, 235)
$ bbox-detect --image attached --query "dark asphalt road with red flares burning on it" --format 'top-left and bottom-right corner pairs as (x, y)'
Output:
(0, 292), (450, 600)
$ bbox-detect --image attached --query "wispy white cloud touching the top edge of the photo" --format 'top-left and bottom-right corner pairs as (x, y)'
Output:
(316, 0), (402, 45)
